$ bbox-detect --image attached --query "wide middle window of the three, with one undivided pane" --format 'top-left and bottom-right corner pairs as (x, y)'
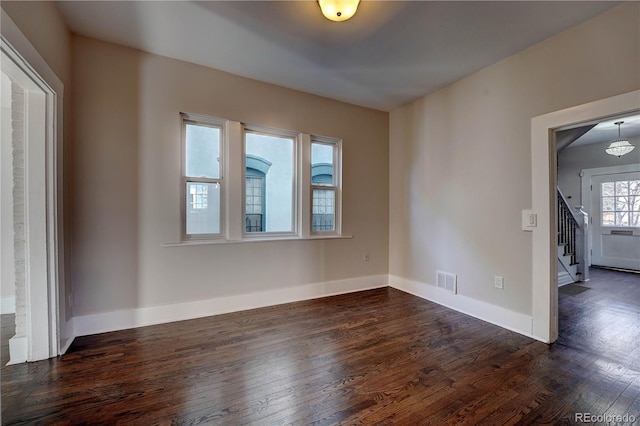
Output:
(244, 128), (296, 234)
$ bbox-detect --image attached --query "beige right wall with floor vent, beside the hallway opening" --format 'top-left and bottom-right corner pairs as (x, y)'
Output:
(389, 3), (640, 315)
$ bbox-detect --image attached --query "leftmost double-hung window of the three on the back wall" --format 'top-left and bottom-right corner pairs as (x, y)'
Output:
(182, 114), (223, 239)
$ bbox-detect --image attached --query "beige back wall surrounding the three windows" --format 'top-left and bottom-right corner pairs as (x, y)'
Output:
(70, 36), (389, 315)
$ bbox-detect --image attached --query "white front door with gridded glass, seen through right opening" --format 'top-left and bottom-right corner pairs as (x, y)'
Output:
(591, 172), (640, 270)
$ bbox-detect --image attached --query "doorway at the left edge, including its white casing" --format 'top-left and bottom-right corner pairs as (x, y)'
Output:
(0, 35), (62, 364)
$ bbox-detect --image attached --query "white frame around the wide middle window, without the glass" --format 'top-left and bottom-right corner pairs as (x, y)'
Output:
(241, 123), (302, 240)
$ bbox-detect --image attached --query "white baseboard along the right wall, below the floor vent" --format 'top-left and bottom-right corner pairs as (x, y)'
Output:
(389, 275), (541, 340)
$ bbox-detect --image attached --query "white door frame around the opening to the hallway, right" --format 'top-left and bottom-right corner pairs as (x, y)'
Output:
(531, 90), (640, 343)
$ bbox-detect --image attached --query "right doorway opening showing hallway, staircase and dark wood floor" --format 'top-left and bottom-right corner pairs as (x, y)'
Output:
(555, 114), (640, 362)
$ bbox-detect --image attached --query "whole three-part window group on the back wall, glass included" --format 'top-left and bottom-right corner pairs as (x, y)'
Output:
(181, 113), (342, 242)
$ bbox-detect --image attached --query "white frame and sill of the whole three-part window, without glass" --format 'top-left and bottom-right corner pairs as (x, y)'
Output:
(178, 112), (342, 246)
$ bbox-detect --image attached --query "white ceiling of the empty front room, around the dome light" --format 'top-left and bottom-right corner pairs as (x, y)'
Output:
(57, 0), (620, 111)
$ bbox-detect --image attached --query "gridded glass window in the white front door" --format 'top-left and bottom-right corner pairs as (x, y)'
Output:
(600, 180), (640, 227)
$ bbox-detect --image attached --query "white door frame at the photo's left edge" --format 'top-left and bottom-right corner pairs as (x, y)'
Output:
(0, 11), (67, 364)
